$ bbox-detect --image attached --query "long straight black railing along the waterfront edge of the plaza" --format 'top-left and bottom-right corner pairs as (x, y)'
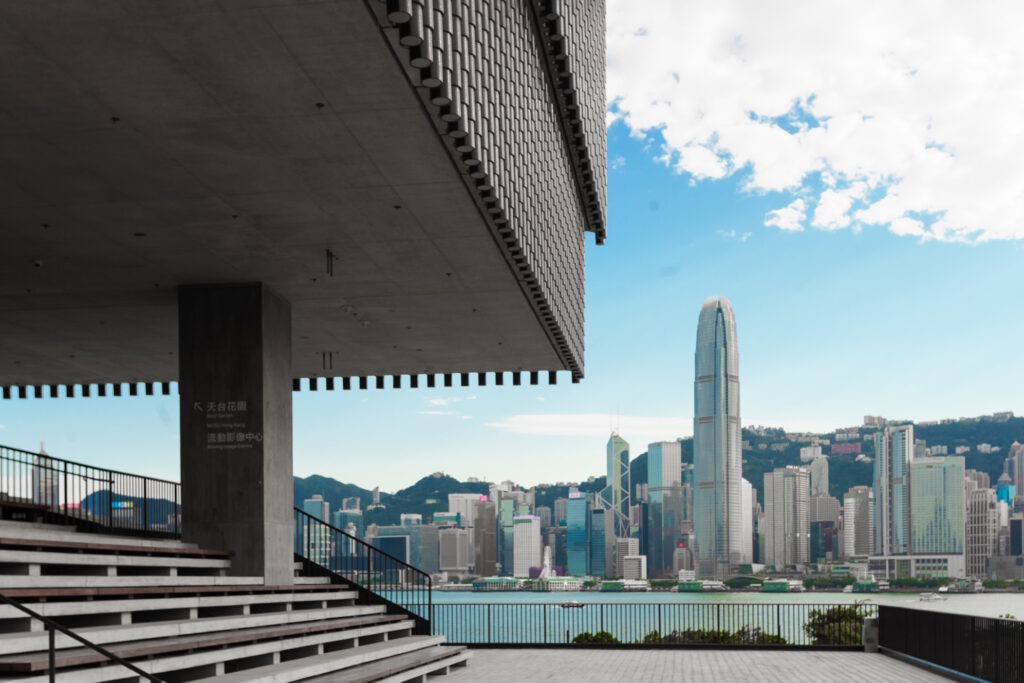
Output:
(419, 601), (878, 649)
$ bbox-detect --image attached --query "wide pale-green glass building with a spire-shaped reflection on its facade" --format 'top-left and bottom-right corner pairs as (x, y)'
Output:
(910, 456), (966, 555)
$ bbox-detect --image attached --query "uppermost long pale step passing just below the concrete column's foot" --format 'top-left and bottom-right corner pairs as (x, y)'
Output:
(0, 590), (358, 618)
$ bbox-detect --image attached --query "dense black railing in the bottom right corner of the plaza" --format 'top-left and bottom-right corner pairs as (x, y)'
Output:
(879, 605), (1024, 683)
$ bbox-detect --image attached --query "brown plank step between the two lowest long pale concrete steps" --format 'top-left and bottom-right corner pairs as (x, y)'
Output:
(0, 614), (415, 673)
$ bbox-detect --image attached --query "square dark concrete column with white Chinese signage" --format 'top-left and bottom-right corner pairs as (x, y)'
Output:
(178, 284), (294, 585)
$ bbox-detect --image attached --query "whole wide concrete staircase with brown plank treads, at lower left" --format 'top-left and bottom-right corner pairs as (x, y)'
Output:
(0, 521), (469, 683)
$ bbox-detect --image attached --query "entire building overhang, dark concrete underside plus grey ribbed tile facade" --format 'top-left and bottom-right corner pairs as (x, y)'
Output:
(0, 0), (604, 393)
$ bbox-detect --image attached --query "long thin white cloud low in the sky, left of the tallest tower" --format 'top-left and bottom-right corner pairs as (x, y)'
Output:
(486, 413), (692, 440)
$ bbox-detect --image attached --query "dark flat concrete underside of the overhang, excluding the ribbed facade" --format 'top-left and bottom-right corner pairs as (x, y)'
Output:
(0, 0), (564, 385)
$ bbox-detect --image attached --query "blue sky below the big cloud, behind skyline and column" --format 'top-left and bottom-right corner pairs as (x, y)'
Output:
(0, 124), (1024, 490)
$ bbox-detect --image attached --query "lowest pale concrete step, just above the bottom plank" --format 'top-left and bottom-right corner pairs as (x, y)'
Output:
(192, 636), (444, 683)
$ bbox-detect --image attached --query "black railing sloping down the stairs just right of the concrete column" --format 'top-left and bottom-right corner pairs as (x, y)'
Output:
(295, 508), (433, 634)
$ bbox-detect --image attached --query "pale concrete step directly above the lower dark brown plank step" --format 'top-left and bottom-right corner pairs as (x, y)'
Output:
(0, 605), (385, 654)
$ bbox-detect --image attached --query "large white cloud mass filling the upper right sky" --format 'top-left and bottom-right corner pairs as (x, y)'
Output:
(607, 0), (1024, 242)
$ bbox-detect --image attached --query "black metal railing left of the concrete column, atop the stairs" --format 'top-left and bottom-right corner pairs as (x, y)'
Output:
(0, 445), (181, 539)
